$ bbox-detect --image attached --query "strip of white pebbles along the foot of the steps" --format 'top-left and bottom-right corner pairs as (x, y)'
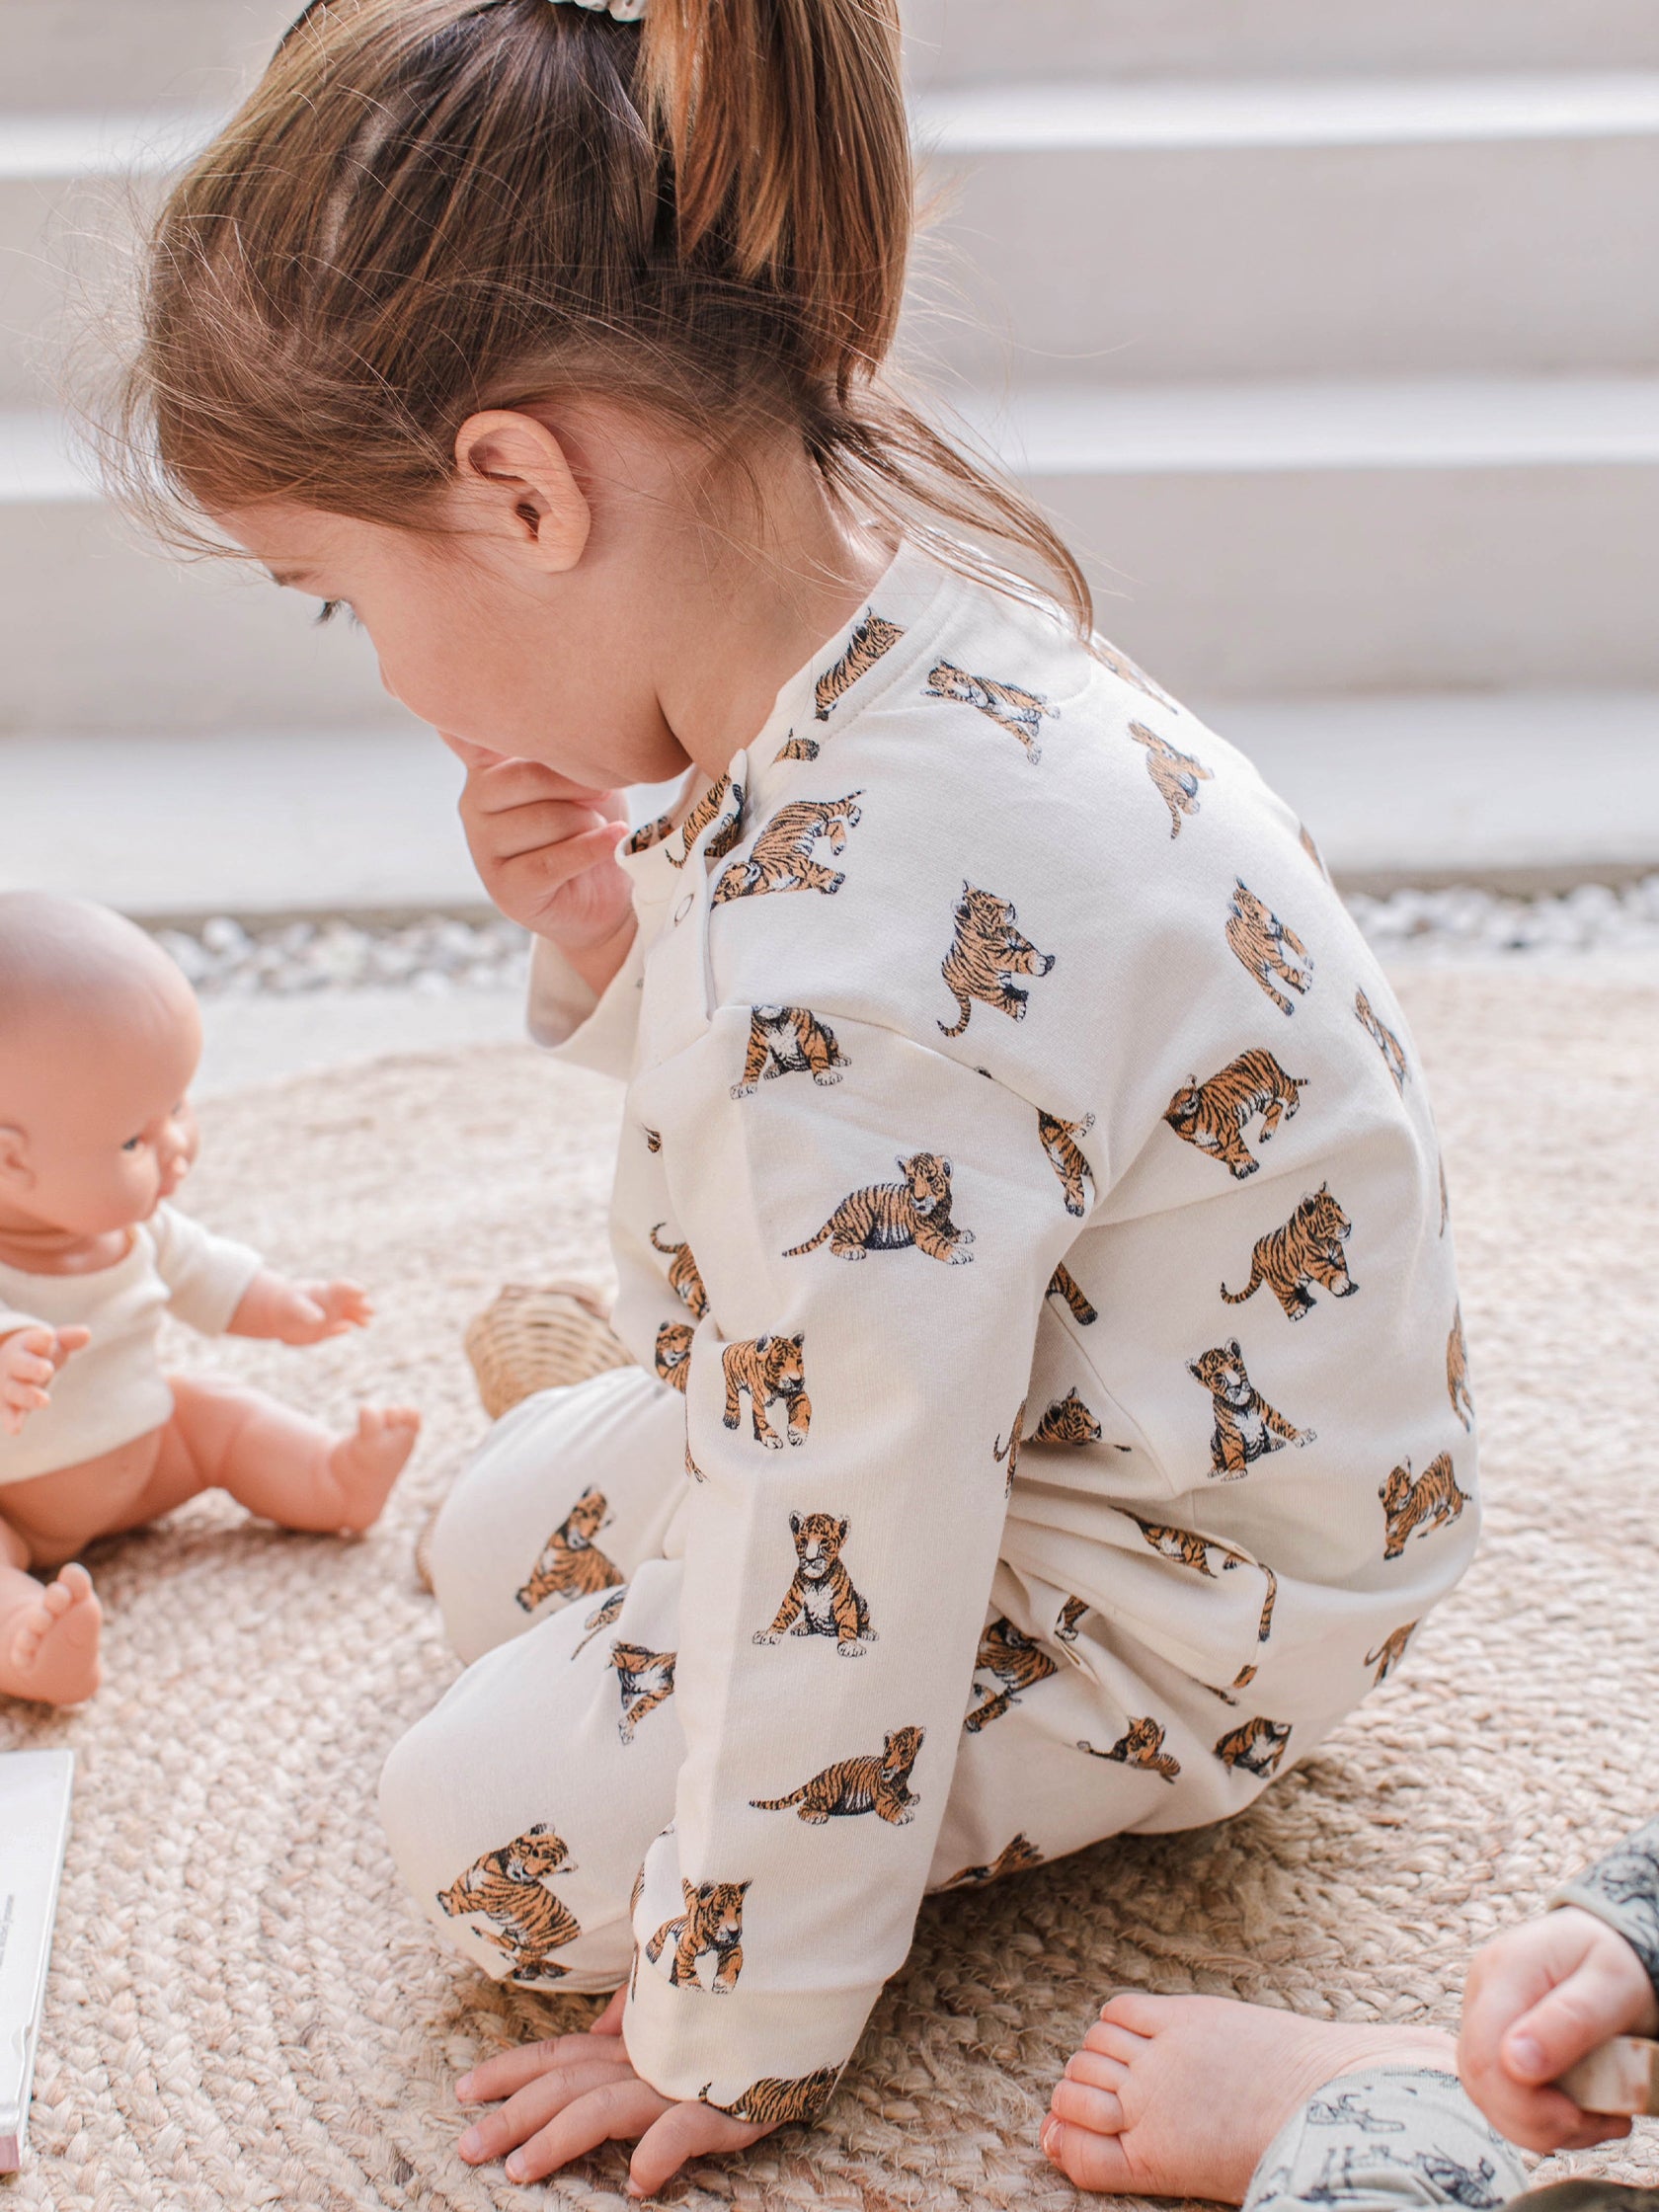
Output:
(157, 874), (1659, 997)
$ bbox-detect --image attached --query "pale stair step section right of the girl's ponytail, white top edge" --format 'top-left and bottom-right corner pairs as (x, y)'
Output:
(909, 75), (1659, 383)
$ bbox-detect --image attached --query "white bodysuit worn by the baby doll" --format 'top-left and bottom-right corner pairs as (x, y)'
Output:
(0, 1206), (261, 1486)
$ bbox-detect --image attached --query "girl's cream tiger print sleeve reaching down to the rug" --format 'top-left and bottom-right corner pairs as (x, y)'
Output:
(626, 1006), (1075, 2117)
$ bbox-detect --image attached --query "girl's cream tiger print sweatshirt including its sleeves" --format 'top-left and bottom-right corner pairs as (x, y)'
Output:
(531, 546), (1477, 2101)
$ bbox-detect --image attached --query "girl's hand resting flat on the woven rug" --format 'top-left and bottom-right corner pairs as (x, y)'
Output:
(455, 1991), (772, 2196)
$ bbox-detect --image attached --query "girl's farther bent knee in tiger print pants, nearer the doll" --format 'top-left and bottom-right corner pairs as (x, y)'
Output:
(427, 1367), (688, 1661)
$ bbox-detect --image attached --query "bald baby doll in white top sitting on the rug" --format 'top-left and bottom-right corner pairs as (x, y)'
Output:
(0, 892), (421, 1705)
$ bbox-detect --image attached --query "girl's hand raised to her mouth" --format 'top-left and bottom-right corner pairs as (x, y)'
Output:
(440, 732), (633, 953)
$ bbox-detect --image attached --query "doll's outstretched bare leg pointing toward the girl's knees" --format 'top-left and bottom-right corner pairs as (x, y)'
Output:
(128, 1376), (421, 1533)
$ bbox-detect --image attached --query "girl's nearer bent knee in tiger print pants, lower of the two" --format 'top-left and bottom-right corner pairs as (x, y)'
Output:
(380, 1559), (685, 1991)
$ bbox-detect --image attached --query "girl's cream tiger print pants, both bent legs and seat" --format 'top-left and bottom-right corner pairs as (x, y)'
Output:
(380, 1367), (1352, 1991)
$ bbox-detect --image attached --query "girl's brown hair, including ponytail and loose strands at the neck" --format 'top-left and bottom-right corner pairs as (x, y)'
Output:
(109, 0), (1093, 637)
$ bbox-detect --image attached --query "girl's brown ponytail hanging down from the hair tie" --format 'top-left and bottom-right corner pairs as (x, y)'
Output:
(644, 0), (913, 400)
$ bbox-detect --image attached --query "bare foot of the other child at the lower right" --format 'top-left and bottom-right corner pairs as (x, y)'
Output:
(1042, 1991), (1458, 2205)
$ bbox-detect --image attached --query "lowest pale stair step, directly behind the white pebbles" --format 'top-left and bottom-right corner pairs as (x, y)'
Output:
(0, 690), (1659, 920)
